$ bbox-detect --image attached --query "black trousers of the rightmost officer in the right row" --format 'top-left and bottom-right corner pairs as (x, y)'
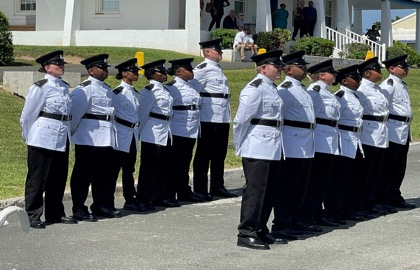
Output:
(376, 141), (410, 203)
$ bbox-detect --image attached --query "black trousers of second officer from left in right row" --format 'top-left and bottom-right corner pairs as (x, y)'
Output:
(272, 157), (313, 231)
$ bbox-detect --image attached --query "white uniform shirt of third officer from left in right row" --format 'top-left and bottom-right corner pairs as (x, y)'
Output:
(308, 81), (341, 155)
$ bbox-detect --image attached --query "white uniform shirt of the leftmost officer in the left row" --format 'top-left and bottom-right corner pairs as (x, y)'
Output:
(20, 74), (72, 152)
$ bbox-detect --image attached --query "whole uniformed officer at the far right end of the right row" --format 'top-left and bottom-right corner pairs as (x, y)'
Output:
(377, 54), (416, 209)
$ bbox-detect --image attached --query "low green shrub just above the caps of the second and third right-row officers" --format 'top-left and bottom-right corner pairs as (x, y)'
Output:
(292, 37), (334, 57)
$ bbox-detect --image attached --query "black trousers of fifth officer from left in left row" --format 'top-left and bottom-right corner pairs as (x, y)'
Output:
(171, 135), (196, 197)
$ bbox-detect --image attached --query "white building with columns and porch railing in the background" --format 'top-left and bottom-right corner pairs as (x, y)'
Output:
(0, 0), (420, 55)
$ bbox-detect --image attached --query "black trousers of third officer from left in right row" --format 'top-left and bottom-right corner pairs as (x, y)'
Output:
(297, 153), (336, 223)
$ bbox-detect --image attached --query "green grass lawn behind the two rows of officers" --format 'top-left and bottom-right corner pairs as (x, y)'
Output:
(0, 46), (420, 199)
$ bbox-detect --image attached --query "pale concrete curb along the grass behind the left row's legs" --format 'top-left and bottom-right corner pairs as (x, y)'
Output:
(0, 168), (244, 210)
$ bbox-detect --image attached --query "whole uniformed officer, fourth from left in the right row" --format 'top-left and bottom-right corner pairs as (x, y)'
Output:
(324, 65), (363, 221)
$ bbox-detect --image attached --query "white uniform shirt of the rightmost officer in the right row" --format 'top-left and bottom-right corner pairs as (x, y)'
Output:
(380, 75), (413, 144)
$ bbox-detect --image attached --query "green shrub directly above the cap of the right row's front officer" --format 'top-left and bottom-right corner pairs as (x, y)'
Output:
(254, 28), (291, 52)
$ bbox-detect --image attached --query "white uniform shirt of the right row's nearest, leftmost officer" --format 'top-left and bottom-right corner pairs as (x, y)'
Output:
(233, 74), (283, 160)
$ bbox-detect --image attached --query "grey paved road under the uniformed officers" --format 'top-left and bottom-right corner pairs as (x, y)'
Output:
(0, 144), (420, 270)
